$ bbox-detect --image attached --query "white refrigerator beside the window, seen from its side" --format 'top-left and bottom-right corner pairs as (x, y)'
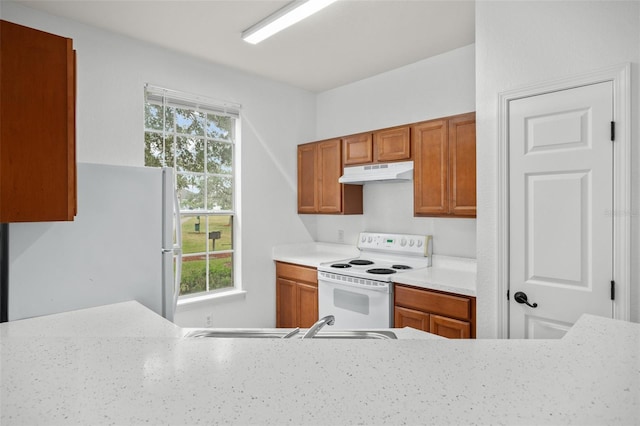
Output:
(8, 163), (181, 321)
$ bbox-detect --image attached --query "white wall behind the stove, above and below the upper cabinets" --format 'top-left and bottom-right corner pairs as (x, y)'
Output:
(312, 45), (476, 258)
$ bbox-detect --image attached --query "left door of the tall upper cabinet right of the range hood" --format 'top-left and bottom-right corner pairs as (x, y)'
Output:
(411, 120), (449, 216)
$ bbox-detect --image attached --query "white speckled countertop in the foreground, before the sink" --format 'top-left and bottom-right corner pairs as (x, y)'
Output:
(0, 302), (640, 425)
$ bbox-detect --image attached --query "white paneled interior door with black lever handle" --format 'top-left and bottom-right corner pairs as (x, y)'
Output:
(509, 82), (613, 338)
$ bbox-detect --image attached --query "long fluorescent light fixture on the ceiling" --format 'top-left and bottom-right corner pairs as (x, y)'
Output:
(242, 0), (336, 44)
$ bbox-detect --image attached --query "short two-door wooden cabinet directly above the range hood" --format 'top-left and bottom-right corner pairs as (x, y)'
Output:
(342, 126), (411, 166)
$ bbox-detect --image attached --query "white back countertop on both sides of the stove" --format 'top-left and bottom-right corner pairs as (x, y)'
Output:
(272, 243), (476, 297)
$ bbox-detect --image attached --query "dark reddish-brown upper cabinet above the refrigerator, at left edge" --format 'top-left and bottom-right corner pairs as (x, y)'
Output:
(0, 21), (77, 223)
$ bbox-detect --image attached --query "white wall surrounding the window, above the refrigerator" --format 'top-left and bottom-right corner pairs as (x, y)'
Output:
(2, 2), (316, 327)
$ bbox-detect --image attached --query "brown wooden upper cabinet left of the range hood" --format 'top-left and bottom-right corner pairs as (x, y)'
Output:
(298, 139), (362, 214)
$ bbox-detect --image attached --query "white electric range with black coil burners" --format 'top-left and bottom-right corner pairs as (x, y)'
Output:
(318, 232), (433, 329)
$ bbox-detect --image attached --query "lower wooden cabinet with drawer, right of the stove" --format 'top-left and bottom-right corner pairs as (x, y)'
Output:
(394, 284), (476, 339)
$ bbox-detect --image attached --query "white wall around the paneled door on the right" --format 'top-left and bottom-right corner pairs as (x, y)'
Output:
(476, 1), (640, 337)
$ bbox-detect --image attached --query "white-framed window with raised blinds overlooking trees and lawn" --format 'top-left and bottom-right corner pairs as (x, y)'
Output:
(144, 85), (240, 296)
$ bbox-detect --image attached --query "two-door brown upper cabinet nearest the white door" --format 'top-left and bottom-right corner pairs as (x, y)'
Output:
(411, 112), (476, 217)
